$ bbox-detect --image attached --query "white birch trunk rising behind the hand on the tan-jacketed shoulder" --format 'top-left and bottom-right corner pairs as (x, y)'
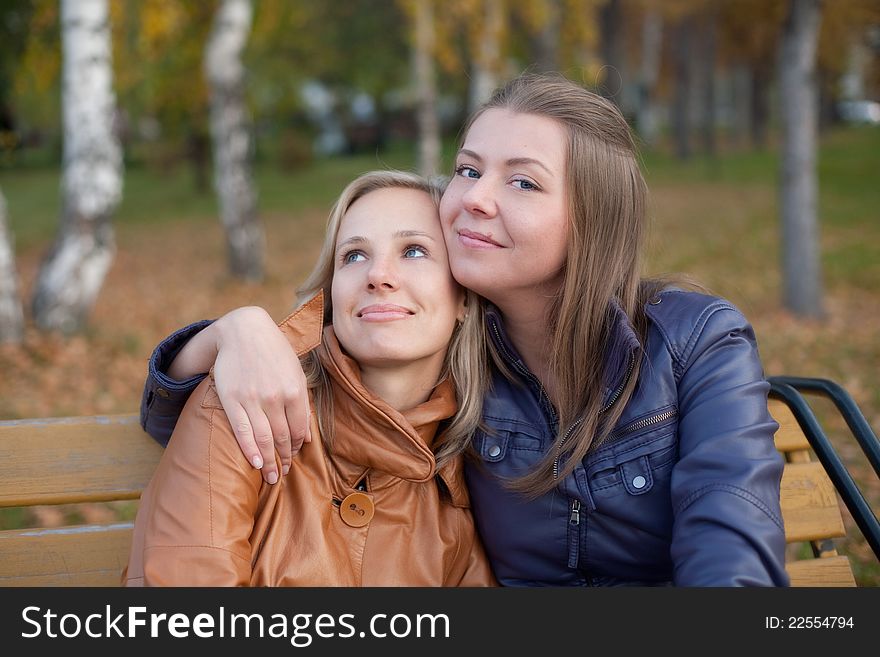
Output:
(205, 0), (265, 281)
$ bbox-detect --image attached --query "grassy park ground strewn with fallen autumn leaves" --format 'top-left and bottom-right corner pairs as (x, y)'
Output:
(0, 127), (880, 586)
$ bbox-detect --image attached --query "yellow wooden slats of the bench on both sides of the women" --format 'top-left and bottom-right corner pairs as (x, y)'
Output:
(0, 399), (868, 586)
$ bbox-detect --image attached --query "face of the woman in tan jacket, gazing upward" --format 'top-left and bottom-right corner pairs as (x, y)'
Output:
(331, 187), (464, 371)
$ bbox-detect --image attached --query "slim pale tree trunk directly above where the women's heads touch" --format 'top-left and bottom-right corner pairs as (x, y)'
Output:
(415, 0), (440, 177)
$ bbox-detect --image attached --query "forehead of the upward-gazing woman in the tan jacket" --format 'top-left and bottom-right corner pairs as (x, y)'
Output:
(338, 187), (440, 239)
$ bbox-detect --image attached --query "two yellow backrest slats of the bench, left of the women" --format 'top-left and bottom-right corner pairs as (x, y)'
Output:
(0, 415), (162, 586)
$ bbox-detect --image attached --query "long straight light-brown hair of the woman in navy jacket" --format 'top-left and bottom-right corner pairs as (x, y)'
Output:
(463, 74), (666, 497)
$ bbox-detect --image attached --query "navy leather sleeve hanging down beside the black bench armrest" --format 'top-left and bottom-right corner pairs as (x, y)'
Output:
(671, 301), (788, 586)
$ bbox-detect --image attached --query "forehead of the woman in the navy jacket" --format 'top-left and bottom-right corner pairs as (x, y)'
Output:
(462, 108), (568, 165)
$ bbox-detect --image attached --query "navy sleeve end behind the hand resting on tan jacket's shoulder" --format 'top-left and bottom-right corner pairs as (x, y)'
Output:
(141, 320), (217, 447)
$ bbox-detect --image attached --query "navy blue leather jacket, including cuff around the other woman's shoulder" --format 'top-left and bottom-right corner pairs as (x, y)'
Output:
(141, 291), (788, 586)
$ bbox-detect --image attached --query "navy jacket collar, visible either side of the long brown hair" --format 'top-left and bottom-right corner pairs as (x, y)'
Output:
(486, 298), (642, 406)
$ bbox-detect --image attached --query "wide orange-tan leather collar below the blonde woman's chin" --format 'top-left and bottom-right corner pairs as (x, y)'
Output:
(279, 292), (469, 506)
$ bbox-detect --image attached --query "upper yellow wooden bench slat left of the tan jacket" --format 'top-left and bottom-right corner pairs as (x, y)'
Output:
(0, 415), (163, 507)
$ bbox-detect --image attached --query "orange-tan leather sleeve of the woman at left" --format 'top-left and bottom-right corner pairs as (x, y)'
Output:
(127, 381), (262, 586)
